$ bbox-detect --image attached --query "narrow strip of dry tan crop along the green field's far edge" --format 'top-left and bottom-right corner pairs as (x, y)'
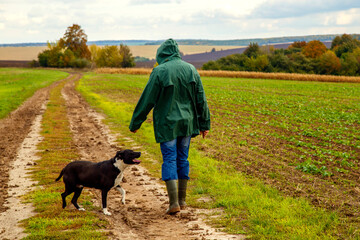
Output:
(95, 68), (360, 83)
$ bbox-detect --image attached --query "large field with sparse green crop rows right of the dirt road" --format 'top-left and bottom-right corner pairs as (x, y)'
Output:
(78, 73), (360, 239)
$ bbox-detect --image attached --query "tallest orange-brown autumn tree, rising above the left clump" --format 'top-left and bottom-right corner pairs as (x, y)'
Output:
(59, 24), (91, 59)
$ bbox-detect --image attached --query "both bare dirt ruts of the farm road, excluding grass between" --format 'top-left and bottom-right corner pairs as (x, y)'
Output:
(0, 74), (244, 239)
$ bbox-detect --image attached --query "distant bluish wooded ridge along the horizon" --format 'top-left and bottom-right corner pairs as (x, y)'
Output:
(0, 34), (360, 47)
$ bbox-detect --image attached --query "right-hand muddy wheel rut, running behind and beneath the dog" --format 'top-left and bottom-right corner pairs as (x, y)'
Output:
(62, 74), (244, 239)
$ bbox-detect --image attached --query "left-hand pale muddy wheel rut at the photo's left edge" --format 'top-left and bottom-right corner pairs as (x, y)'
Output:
(0, 76), (74, 239)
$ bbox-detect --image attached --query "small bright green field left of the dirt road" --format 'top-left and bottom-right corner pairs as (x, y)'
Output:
(0, 68), (68, 119)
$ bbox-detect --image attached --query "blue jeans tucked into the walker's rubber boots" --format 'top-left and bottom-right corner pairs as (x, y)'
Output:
(160, 136), (191, 181)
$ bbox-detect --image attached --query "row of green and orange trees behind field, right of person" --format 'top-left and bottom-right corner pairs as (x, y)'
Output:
(202, 34), (360, 76)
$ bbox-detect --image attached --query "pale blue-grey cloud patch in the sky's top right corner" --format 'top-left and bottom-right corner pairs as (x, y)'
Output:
(250, 0), (360, 19)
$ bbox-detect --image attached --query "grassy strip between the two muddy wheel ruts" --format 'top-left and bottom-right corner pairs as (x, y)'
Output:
(24, 76), (107, 240)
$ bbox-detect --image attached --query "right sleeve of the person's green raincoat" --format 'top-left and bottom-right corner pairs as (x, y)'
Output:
(196, 74), (210, 131)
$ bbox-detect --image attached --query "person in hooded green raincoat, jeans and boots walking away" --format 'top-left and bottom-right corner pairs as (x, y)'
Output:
(129, 39), (210, 214)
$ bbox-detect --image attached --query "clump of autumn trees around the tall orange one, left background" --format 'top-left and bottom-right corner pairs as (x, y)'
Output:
(33, 24), (135, 68)
